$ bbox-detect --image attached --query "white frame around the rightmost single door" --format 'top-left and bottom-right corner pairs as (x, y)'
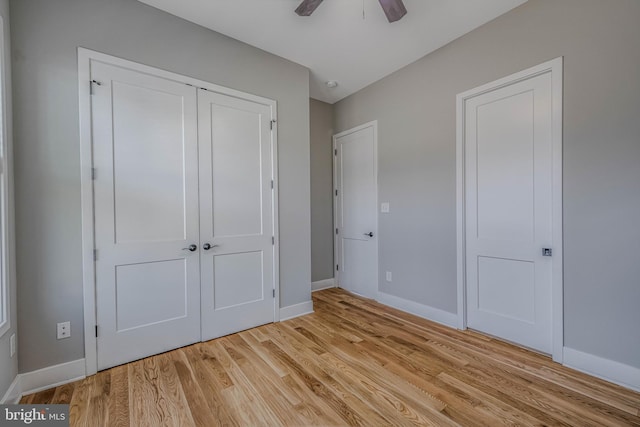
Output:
(456, 57), (564, 363)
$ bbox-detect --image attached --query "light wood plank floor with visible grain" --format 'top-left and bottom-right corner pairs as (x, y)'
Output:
(22, 289), (640, 427)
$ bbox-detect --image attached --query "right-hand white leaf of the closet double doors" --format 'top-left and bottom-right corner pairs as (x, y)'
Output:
(198, 90), (275, 340)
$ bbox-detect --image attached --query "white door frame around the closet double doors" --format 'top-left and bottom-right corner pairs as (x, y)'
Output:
(78, 47), (280, 376)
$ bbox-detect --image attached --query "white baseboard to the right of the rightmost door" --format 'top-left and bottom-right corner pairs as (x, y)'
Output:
(563, 347), (640, 391)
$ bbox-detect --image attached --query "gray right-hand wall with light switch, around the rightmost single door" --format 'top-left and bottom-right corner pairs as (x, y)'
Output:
(335, 0), (640, 367)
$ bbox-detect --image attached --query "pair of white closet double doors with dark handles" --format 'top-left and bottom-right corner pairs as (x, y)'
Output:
(91, 62), (275, 369)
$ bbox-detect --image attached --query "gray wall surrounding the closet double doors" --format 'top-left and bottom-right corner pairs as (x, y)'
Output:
(11, 0), (311, 372)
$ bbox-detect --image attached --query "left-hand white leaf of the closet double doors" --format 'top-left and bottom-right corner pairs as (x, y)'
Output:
(91, 62), (200, 369)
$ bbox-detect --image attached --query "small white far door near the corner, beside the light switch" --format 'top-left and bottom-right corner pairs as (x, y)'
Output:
(334, 122), (378, 298)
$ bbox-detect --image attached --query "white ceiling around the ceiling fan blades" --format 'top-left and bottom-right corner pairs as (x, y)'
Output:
(140, 0), (527, 103)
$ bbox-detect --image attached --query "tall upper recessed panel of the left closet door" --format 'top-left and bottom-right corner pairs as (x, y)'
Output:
(112, 81), (186, 243)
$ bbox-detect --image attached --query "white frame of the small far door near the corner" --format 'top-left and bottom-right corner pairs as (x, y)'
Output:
(332, 120), (380, 301)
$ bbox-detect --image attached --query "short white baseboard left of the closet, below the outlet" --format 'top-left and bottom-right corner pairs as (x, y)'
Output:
(19, 359), (86, 395)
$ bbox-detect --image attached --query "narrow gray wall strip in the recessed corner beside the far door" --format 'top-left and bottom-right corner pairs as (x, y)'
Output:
(309, 99), (333, 282)
